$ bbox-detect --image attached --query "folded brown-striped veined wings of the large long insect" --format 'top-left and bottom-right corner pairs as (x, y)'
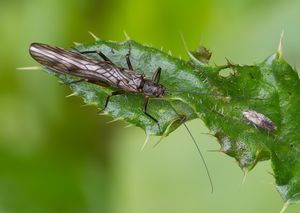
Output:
(29, 43), (144, 92)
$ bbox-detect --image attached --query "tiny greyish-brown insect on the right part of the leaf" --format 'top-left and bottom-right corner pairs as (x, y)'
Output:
(243, 110), (277, 132)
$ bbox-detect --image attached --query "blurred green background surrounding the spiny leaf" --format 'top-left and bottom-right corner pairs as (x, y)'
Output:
(0, 0), (300, 213)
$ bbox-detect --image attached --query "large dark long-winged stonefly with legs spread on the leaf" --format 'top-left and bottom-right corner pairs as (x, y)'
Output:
(29, 43), (165, 130)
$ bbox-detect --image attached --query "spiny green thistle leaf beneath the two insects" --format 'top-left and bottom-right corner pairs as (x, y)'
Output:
(45, 40), (300, 206)
